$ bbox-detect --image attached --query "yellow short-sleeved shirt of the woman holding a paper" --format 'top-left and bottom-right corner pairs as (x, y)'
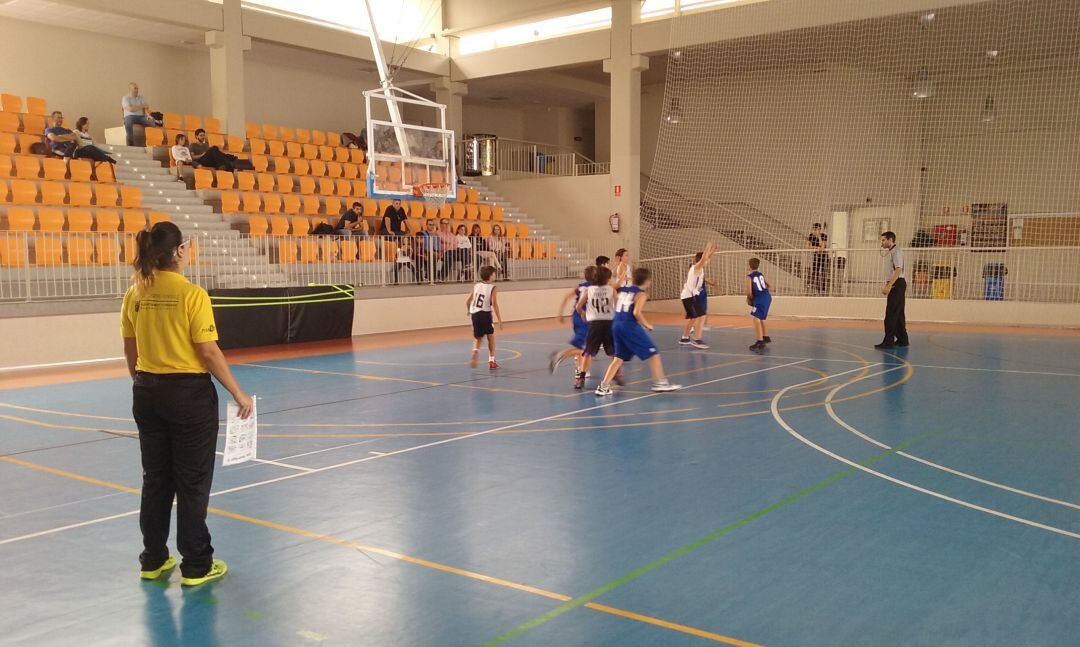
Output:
(120, 271), (217, 374)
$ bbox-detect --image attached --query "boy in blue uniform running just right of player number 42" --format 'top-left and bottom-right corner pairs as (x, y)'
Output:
(596, 268), (681, 395)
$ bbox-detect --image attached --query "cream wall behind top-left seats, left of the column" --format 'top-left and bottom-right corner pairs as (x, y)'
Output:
(0, 15), (211, 140)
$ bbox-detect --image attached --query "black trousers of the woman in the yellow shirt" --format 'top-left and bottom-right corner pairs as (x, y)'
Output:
(132, 373), (218, 577)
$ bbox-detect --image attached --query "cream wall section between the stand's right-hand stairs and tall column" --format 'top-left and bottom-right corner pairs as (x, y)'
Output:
(483, 175), (622, 251)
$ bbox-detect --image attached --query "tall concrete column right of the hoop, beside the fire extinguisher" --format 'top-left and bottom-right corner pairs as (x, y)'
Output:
(604, 0), (649, 259)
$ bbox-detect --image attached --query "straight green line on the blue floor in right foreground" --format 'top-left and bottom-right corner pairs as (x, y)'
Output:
(481, 431), (937, 647)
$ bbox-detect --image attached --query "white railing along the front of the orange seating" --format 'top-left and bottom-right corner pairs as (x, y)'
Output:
(0, 231), (598, 301)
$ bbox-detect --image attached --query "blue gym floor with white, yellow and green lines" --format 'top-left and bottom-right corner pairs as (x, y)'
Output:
(0, 324), (1080, 646)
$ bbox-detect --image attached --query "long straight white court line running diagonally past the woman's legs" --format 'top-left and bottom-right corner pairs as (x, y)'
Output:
(0, 362), (807, 545)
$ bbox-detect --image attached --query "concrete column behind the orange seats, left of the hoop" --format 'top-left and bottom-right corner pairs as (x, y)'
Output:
(206, 0), (252, 136)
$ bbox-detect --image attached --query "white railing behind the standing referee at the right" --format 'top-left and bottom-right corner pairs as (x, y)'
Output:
(638, 247), (1080, 304)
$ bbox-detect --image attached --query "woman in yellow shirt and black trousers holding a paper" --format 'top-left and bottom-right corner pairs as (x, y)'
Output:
(121, 223), (252, 585)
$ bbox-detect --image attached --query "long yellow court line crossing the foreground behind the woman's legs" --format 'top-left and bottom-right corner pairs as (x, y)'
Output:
(0, 456), (753, 646)
